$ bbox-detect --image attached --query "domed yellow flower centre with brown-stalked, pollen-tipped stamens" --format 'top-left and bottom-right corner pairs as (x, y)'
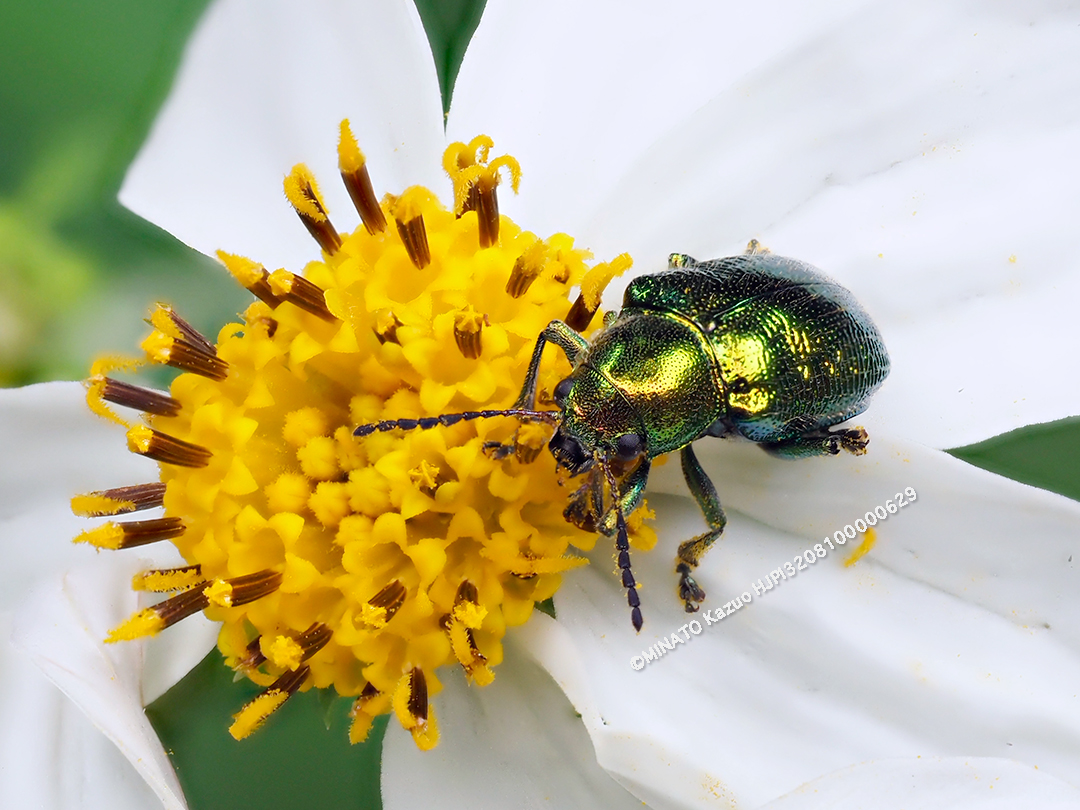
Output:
(71, 126), (656, 750)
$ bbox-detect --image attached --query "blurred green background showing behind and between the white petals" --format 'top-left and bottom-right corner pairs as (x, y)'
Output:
(0, 0), (1080, 810)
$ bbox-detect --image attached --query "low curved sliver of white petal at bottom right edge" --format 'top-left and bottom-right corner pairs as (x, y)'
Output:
(762, 757), (1080, 810)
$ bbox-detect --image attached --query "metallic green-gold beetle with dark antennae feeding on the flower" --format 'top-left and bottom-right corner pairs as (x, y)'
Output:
(355, 241), (889, 631)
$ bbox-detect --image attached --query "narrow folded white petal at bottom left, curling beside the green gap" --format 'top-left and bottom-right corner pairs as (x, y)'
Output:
(12, 557), (187, 808)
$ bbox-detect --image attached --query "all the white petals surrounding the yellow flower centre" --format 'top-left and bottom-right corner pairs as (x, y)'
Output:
(6, 0), (1080, 810)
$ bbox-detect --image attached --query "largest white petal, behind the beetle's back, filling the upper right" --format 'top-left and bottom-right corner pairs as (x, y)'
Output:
(450, 2), (1080, 446)
